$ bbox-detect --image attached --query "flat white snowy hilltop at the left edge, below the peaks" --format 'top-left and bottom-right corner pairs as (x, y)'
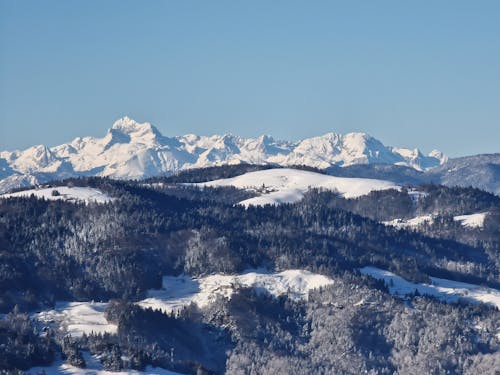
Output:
(0, 186), (113, 203)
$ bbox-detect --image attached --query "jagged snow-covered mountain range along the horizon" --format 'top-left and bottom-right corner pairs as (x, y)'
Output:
(0, 117), (447, 192)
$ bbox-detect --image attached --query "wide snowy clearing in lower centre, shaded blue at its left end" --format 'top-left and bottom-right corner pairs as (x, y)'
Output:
(138, 270), (333, 313)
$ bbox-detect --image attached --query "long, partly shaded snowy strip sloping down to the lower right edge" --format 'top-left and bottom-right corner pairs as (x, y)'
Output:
(360, 267), (500, 308)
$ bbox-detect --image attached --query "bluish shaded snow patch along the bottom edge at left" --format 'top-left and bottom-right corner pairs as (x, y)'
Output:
(26, 352), (181, 375)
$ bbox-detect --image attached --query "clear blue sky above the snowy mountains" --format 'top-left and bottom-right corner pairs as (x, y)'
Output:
(0, 0), (500, 156)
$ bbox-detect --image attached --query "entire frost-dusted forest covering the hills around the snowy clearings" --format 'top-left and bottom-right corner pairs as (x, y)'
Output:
(0, 167), (500, 373)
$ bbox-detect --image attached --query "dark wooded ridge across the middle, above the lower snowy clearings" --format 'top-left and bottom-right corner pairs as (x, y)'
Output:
(0, 179), (498, 309)
